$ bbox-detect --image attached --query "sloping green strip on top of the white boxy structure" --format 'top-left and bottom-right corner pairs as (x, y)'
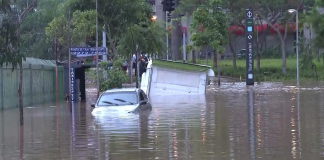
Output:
(153, 59), (209, 72)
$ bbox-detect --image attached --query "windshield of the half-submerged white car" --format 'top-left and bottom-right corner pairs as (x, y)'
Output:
(98, 92), (138, 106)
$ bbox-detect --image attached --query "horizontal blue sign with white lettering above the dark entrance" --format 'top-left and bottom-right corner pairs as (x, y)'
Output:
(70, 47), (107, 56)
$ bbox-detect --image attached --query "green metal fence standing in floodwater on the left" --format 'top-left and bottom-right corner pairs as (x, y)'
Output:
(0, 58), (64, 109)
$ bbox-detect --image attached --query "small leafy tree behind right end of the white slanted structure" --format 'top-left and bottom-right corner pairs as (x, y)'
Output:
(191, 0), (228, 85)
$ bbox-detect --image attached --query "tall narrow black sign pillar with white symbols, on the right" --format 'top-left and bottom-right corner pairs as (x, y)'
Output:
(245, 9), (254, 85)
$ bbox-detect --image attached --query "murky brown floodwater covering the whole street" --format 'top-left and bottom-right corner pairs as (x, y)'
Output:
(0, 83), (324, 160)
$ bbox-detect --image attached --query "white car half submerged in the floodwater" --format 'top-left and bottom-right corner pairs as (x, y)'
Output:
(91, 88), (152, 114)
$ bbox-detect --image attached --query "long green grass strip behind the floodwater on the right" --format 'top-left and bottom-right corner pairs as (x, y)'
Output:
(198, 58), (324, 81)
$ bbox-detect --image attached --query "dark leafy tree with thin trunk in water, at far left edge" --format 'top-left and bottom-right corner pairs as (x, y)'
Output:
(0, 0), (37, 125)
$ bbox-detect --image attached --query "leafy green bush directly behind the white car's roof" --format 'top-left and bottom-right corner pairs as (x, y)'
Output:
(99, 60), (127, 91)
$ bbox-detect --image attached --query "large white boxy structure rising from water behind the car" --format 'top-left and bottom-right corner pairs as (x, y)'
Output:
(141, 58), (215, 96)
